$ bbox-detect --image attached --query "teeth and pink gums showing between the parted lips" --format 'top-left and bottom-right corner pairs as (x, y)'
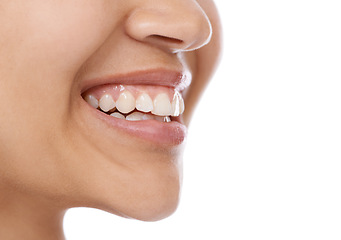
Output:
(82, 84), (185, 123)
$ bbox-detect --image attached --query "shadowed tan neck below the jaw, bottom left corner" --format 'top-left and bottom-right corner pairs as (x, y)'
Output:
(0, 185), (65, 240)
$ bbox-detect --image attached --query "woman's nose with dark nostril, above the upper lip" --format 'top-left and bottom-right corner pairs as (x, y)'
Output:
(125, 0), (212, 53)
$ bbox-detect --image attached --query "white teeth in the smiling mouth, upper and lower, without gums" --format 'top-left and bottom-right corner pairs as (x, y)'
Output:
(84, 90), (185, 122)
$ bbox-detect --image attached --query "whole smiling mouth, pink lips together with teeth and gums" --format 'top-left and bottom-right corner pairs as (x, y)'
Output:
(81, 71), (190, 145)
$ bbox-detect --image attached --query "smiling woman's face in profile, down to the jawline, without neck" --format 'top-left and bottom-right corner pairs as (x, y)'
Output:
(0, 0), (219, 220)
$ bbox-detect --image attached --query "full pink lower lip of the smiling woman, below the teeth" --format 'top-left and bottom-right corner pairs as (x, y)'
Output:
(82, 99), (187, 146)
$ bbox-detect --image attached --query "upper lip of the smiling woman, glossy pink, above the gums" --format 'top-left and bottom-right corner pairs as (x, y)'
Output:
(81, 69), (192, 93)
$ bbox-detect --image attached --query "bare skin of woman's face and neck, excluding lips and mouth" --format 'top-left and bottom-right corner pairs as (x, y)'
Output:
(0, 0), (221, 239)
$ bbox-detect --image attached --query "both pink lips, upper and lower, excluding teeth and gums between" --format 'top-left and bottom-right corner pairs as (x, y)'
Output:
(81, 70), (191, 146)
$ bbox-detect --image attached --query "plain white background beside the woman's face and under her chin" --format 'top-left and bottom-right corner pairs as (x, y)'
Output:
(64, 0), (341, 240)
